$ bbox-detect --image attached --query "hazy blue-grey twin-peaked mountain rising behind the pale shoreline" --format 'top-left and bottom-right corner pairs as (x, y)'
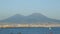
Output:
(0, 13), (60, 23)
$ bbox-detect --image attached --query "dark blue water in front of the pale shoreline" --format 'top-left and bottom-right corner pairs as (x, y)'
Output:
(0, 27), (60, 34)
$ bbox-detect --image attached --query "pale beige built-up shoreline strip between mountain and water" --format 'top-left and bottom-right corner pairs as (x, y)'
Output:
(0, 24), (60, 28)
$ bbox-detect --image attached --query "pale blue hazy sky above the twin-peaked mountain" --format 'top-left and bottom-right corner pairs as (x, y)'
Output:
(0, 0), (60, 20)
